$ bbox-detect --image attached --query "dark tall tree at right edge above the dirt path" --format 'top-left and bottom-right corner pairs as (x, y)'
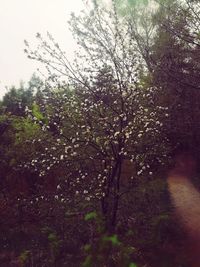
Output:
(152, 1), (200, 154)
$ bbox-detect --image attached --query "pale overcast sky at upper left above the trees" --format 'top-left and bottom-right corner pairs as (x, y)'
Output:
(0, 0), (83, 97)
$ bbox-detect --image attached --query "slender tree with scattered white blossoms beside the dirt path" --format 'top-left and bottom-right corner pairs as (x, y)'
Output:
(26, 1), (168, 230)
